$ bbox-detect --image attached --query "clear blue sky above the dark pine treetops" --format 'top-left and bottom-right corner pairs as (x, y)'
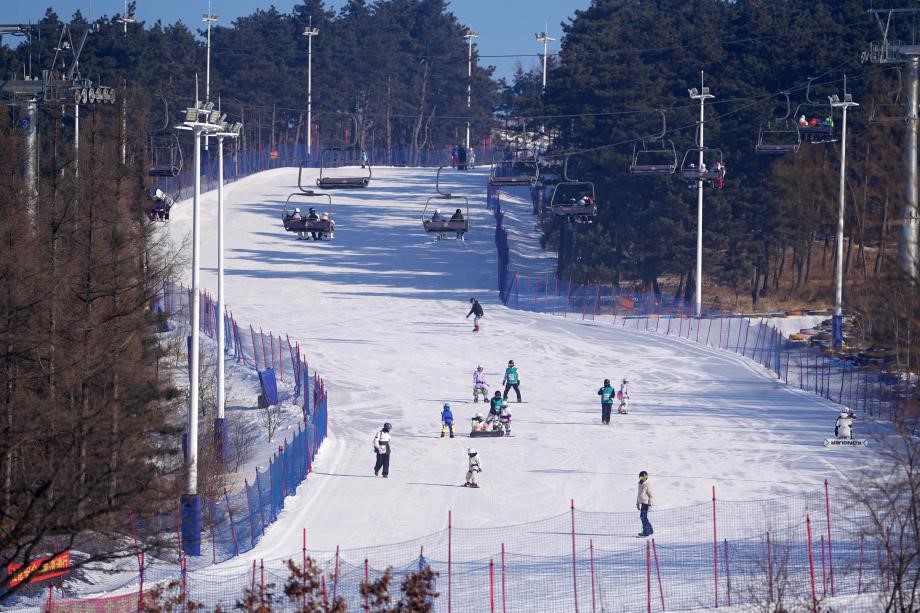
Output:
(0, 0), (591, 78)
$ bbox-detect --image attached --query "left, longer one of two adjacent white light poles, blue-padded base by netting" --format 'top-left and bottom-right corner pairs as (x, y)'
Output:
(176, 102), (223, 556)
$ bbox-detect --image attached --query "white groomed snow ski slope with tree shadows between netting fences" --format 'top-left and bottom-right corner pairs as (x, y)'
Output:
(168, 168), (871, 559)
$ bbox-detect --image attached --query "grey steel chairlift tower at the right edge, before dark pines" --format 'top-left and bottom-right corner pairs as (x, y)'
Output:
(863, 8), (920, 282)
